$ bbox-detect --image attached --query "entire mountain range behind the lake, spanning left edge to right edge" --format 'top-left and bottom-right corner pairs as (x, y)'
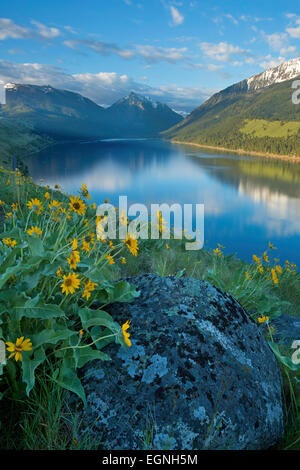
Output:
(0, 58), (300, 157)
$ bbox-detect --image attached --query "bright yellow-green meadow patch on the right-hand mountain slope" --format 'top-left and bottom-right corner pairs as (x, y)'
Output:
(240, 119), (300, 137)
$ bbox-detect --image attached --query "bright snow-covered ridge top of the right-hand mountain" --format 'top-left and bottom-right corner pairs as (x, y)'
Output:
(247, 58), (300, 91)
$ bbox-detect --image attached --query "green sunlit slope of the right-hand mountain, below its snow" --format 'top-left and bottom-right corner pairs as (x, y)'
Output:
(162, 75), (300, 156)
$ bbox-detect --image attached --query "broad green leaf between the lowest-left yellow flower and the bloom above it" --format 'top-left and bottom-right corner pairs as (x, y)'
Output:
(16, 294), (65, 320)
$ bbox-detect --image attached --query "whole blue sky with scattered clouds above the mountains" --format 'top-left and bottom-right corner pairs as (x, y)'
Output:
(0, 0), (300, 111)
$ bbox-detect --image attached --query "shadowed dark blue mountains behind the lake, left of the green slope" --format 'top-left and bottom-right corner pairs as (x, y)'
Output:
(0, 83), (182, 140)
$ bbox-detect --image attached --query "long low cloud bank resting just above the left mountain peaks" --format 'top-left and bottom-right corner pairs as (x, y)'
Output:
(0, 60), (216, 111)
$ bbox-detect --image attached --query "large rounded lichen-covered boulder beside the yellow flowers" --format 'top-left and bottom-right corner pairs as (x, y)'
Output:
(72, 274), (283, 450)
